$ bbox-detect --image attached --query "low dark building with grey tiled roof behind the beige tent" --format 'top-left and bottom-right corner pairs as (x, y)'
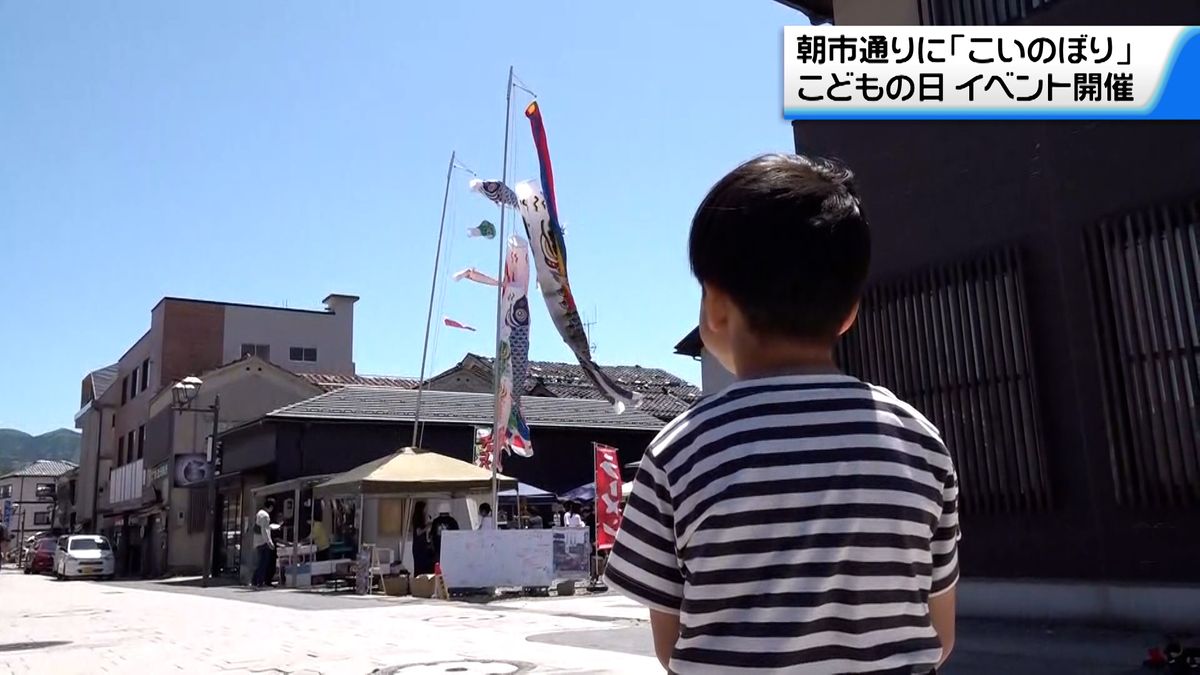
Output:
(220, 384), (665, 574)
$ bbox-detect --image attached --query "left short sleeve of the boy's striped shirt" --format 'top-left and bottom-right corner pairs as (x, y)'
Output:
(605, 453), (683, 614)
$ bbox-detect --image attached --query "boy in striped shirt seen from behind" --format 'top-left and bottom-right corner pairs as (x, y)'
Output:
(605, 155), (958, 675)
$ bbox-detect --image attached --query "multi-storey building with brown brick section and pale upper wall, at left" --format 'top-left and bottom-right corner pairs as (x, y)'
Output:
(76, 294), (358, 573)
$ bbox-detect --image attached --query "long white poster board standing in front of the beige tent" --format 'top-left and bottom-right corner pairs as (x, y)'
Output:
(442, 528), (590, 589)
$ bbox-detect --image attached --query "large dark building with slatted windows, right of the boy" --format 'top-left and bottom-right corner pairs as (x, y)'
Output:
(680, 0), (1200, 628)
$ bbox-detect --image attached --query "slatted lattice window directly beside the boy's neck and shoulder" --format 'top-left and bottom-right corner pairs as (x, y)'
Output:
(838, 243), (1051, 513)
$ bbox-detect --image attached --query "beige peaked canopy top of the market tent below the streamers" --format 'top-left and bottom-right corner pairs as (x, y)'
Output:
(313, 448), (517, 497)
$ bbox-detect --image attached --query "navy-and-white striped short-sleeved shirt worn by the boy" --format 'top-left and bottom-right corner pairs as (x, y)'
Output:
(605, 375), (959, 675)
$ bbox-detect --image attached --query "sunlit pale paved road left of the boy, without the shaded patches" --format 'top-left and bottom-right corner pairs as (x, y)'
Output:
(0, 571), (658, 675)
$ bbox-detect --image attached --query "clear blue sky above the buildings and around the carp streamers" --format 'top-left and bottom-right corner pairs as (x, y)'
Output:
(0, 0), (804, 432)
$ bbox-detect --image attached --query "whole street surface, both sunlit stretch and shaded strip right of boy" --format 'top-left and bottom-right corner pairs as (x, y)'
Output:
(0, 569), (1159, 675)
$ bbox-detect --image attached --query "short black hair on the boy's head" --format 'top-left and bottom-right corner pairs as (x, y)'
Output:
(688, 155), (871, 341)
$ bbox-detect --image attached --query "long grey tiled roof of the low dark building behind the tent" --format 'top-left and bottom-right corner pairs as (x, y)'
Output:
(266, 384), (664, 431)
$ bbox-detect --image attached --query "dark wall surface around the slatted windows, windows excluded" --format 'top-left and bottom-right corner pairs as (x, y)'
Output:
(794, 114), (1200, 581)
